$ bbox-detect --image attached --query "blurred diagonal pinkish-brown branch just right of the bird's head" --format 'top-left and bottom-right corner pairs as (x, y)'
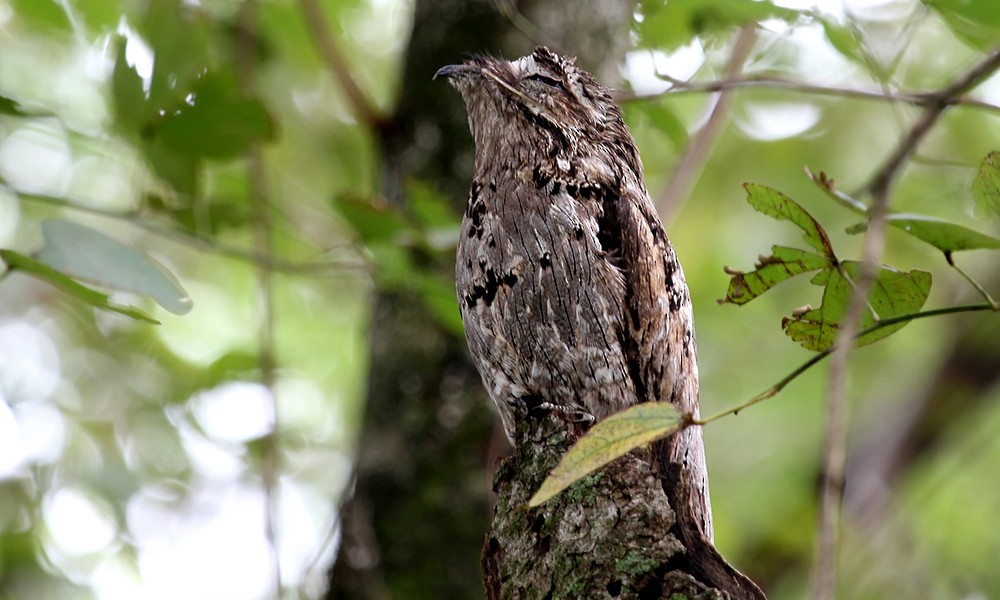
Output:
(656, 23), (757, 217)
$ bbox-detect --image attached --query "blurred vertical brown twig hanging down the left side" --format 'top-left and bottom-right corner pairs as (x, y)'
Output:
(236, 0), (282, 600)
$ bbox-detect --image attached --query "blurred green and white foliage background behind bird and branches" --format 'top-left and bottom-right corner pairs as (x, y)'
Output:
(0, 0), (1000, 600)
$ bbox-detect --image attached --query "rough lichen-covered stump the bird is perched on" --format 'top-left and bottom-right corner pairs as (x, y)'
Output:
(482, 414), (726, 600)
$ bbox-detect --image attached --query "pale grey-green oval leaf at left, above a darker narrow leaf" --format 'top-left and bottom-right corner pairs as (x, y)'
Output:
(37, 219), (191, 315)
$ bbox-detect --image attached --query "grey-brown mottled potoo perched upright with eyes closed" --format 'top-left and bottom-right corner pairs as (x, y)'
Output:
(436, 47), (712, 540)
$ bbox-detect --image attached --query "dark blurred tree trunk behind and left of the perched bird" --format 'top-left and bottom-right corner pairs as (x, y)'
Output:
(328, 0), (506, 599)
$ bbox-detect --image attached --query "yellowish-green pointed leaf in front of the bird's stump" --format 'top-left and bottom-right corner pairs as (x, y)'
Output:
(528, 402), (685, 506)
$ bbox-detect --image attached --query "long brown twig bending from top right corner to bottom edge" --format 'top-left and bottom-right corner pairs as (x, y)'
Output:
(812, 43), (1000, 600)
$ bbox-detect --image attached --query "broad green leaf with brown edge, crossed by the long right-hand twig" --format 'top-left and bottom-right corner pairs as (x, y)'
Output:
(781, 261), (931, 352)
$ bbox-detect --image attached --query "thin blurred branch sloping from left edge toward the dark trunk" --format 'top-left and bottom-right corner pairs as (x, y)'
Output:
(12, 190), (370, 274)
